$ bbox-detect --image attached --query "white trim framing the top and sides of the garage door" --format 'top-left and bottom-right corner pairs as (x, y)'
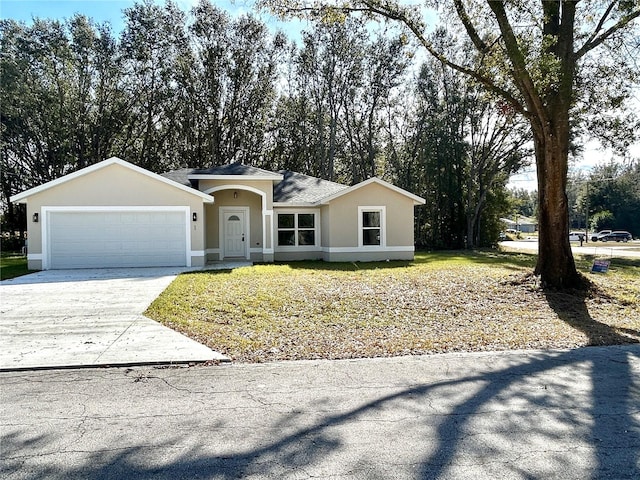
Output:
(40, 205), (191, 270)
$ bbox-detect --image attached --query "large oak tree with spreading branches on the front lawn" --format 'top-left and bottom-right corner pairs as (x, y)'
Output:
(264, 0), (640, 288)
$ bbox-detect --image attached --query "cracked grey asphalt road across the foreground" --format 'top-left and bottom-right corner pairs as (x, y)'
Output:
(0, 345), (640, 480)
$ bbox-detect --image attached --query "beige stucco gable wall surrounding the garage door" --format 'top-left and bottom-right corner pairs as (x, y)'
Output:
(22, 164), (205, 269)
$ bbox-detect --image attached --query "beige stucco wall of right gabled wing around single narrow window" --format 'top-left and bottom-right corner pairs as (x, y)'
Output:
(323, 183), (414, 247)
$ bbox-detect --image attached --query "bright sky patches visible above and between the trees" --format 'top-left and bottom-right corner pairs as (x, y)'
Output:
(0, 0), (640, 190)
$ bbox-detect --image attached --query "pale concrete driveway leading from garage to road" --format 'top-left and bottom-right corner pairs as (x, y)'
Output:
(0, 268), (226, 370)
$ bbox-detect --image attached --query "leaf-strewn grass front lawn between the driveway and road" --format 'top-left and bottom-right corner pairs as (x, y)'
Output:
(146, 252), (640, 362)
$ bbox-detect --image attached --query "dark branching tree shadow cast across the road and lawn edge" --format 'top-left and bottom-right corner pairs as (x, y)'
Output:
(0, 316), (640, 479)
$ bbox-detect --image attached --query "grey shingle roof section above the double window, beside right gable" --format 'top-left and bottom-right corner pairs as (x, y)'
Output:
(273, 170), (349, 203)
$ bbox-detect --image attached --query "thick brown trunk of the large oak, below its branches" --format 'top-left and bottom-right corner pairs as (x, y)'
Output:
(534, 125), (580, 289)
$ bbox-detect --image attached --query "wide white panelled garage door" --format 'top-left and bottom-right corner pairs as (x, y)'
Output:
(47, 210), (187, 269)
